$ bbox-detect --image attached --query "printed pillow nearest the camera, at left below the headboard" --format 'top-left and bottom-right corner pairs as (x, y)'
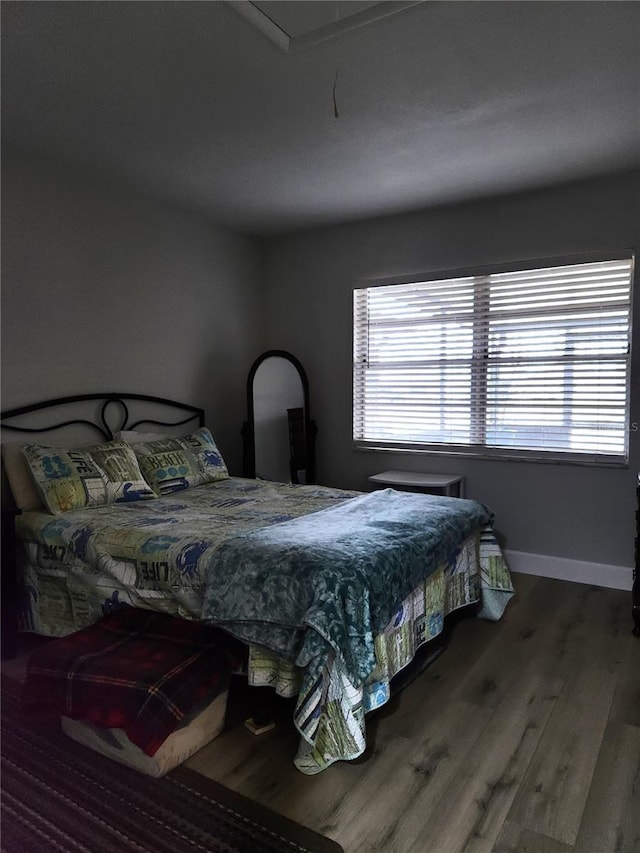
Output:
(23, 441), (155, 514)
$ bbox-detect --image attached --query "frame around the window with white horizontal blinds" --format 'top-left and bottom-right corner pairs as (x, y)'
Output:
(351, 248), (640, 468)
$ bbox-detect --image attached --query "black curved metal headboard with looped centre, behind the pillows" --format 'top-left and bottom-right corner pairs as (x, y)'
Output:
(0, 393), (204, 440)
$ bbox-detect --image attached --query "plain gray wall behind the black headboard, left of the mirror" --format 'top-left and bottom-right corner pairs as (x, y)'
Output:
(2, 151), (261, 473)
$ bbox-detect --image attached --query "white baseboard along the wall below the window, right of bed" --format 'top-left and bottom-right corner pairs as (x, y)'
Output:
(504, 551), (633, 590)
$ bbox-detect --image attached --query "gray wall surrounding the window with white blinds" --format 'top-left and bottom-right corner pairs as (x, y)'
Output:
(263, 175), (640, 566)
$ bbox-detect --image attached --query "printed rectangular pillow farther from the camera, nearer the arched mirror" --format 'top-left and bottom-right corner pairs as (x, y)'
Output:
(133, 427), (229, 495)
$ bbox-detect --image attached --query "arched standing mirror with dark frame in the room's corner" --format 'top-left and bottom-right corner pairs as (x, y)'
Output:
(242, 350), (316, 483)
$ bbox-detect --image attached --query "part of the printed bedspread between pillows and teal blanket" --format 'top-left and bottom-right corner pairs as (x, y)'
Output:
(16, 478), (360, 637)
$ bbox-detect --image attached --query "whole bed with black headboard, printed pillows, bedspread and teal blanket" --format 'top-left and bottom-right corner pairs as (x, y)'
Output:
(2, 394), (513, 774)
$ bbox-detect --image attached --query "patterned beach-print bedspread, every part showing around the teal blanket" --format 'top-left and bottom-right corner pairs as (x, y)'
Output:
(18, 478), (513, 773)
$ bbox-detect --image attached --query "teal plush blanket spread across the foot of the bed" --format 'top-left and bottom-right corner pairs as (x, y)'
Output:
(202, 489), (493, 684)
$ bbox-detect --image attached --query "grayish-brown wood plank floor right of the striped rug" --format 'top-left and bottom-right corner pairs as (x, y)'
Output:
(187, 575), (640, 853)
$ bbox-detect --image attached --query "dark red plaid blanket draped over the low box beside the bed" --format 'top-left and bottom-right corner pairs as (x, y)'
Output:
(22, 607), (244, 755)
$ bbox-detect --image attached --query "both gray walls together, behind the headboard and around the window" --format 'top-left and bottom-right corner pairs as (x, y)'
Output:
(2, 151), (640, 566)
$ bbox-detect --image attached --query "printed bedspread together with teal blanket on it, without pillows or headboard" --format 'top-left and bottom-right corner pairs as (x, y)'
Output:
(17, 478), (513, 773)
